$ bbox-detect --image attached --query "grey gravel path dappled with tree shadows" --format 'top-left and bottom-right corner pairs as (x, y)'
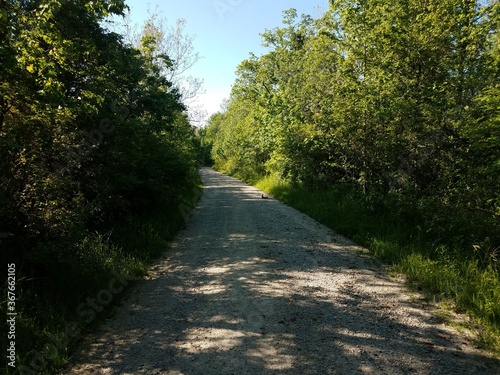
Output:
(64, 168), (500, 375)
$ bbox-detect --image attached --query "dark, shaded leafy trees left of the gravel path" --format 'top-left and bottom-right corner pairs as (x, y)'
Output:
(0, 0), (198, 370)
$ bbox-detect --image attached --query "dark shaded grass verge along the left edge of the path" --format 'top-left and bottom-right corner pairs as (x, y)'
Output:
(2, 177), (201, 374)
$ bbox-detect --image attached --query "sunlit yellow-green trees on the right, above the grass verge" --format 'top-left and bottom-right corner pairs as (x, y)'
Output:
(205, 0), (500, 247)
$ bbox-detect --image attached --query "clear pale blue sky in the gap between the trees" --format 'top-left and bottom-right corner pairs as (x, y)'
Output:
(115, 0), (328, 125)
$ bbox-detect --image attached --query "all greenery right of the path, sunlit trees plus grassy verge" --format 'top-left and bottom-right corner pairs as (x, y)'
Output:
(201, 0), (500, 354)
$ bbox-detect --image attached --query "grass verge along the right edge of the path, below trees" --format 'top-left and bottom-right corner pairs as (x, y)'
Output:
(255, 177), (500, 356)
